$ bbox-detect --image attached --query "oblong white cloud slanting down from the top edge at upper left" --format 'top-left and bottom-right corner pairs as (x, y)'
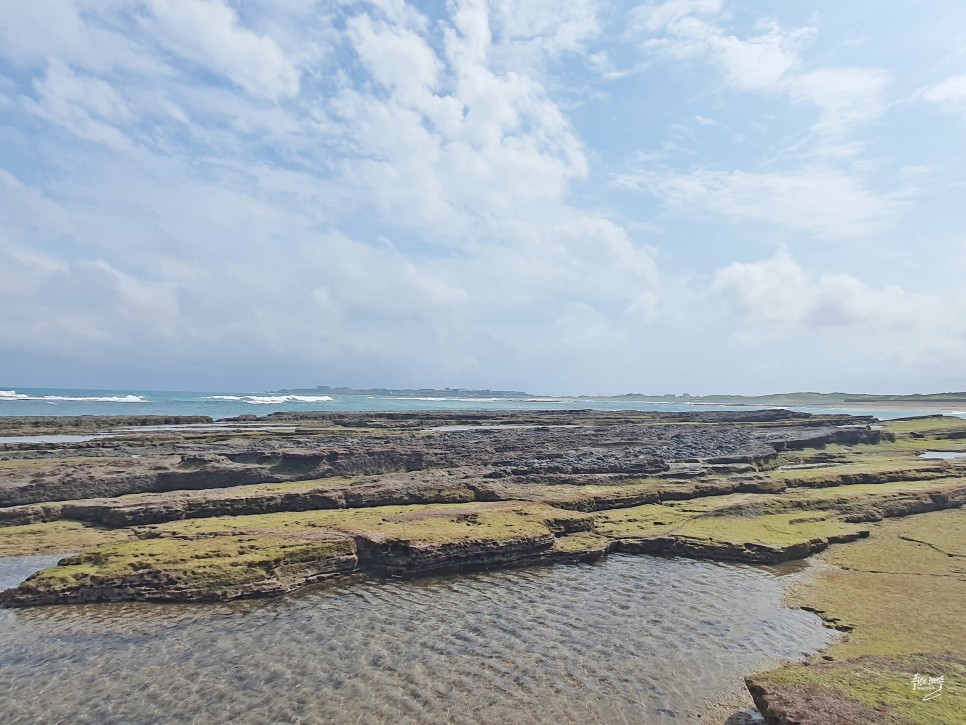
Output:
(147, 0), (299, 100)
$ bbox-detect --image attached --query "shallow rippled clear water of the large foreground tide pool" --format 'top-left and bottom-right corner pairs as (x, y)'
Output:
(0, 556), (832, 723)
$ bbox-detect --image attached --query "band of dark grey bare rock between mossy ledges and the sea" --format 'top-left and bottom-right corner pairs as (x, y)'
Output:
(0, 410), (881, 507)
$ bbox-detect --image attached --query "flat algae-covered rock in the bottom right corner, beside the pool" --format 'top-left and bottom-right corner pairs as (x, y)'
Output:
(746, 509), (966, 725)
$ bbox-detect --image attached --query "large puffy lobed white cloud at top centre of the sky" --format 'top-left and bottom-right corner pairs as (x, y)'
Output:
(330, 2), (587, 236)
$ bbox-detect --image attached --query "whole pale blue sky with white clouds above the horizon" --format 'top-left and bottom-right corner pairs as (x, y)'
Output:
(0, 0), (966, 394)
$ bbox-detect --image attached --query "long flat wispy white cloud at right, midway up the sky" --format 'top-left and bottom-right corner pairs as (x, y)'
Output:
(616, 167), (906, 239)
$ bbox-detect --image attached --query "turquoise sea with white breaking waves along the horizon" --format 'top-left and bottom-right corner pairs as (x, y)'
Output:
(0, 387), (966, 419)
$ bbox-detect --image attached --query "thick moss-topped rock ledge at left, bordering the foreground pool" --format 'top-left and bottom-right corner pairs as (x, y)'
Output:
(0, 503), (603, 606)
